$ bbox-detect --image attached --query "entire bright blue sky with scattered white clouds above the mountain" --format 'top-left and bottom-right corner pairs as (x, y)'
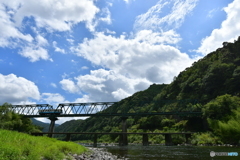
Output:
(0, 0), (240, 122)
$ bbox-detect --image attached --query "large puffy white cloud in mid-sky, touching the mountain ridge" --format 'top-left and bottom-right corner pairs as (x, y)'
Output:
(76, 33), (193, 83)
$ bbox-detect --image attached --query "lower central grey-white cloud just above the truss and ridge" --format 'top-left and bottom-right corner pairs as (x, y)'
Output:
(61, 69), (151, 103)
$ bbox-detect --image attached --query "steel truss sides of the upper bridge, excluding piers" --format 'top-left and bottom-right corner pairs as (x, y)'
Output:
(8, 100), (201, 117)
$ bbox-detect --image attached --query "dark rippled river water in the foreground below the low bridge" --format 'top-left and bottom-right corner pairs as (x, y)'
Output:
(85, 145), (240, 160)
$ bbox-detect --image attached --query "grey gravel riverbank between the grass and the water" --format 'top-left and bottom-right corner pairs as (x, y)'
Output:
(68, 147), (127, 160)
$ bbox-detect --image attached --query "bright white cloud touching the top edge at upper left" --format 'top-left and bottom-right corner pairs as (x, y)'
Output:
(2, 0), (99, 31)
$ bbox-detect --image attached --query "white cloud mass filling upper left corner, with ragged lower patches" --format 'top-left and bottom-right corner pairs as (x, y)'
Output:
(0, 0), (99, 62)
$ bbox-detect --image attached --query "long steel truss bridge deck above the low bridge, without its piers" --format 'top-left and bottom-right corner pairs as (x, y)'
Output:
(11, 100), (202, 118)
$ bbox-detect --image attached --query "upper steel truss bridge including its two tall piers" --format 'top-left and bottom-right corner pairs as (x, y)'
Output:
(11, 100), (202, 145)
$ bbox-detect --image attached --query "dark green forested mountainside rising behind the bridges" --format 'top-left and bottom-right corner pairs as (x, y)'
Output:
(56, 37), (240, 143)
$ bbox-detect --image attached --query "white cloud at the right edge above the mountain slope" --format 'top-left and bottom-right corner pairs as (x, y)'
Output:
(197, 0), (240, 55)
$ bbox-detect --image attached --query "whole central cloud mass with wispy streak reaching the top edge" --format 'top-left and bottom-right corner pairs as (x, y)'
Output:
(65, 0), (197, 102)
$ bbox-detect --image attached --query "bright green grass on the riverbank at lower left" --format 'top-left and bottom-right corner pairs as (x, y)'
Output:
(0, 129), (87, 160)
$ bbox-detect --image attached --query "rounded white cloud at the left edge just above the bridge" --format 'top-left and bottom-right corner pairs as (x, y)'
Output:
(0, 74), (40, 104)
